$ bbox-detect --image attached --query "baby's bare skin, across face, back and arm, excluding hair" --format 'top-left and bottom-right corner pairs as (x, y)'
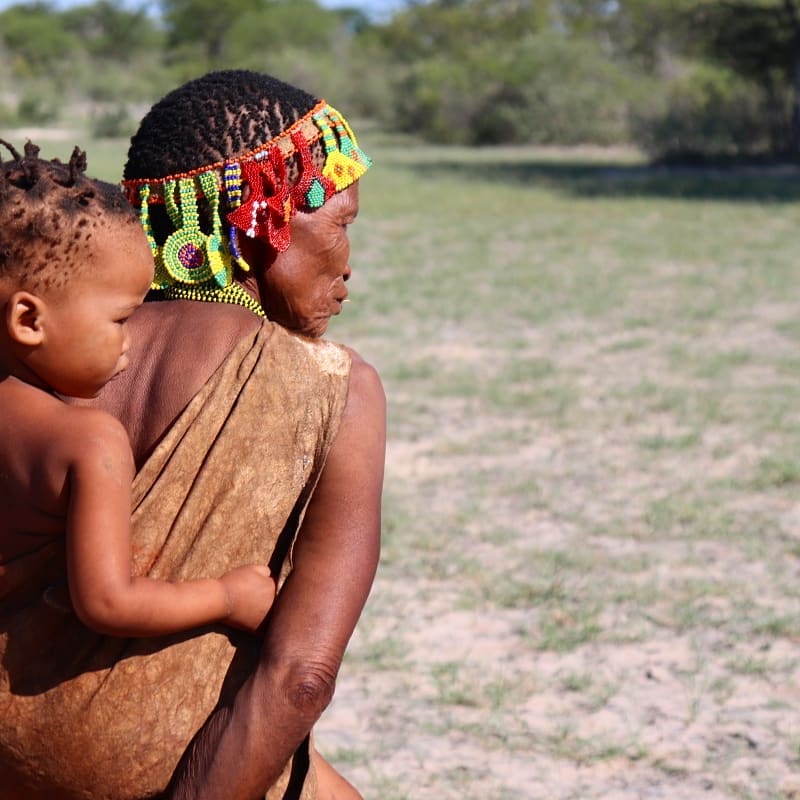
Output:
(0, 220), (275, 636)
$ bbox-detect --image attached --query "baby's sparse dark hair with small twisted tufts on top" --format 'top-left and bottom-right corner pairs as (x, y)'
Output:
(0, 139), (138, 289)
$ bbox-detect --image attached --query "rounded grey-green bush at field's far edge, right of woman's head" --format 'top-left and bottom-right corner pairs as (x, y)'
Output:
(394, 34), (633, 145)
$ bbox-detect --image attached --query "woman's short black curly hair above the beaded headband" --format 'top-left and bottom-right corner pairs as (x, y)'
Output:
(124, 70), (325, 180)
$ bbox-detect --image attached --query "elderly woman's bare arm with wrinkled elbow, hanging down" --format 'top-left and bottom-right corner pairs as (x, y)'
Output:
(167, 355), (386, 800)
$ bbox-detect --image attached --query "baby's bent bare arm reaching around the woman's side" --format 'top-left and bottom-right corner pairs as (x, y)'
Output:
(66, 408), (275, 636)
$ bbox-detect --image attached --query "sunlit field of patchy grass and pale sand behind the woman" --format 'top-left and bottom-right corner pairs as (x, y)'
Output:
(9, 122), (800, 800)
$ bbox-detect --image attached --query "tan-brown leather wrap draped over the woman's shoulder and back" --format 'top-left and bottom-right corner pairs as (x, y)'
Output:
(0, 322), (350, 800)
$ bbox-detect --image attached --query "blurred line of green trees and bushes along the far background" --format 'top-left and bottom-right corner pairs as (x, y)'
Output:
(0, 0), (800, 159)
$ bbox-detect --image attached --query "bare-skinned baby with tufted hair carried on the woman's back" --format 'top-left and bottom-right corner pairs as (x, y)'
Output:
(0, 140), (275, 636)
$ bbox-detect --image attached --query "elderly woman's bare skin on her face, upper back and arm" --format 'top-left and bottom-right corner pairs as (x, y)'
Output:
(86, 184), (386, 800)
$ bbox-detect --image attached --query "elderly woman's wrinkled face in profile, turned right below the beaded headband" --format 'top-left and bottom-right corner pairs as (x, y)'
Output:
(239, 182), (358, 337)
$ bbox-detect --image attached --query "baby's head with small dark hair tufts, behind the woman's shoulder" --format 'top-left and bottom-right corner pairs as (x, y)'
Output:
(0, 140), (153, 397)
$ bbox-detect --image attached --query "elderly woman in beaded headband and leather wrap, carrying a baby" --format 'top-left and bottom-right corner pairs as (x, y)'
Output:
(0, 71), (385, 800)
